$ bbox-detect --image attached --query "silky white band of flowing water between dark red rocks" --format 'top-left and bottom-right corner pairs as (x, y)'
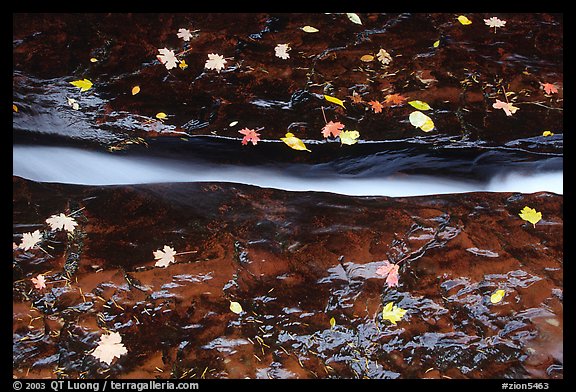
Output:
(12, 145), (563, 197)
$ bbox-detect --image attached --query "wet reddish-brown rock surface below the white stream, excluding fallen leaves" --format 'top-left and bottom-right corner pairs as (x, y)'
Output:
(13, 177), (563, 379)
